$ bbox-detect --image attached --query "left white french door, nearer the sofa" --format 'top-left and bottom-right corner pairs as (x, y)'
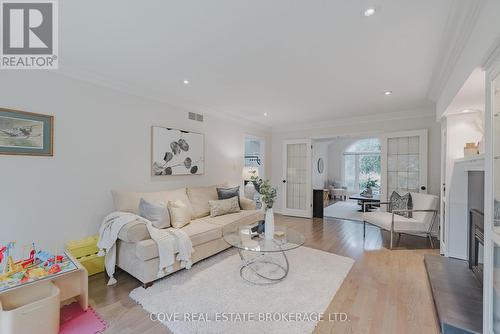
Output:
(282, 139), (312, 218)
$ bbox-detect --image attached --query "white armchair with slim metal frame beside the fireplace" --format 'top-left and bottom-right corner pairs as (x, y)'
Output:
(363, 193), (439, 249)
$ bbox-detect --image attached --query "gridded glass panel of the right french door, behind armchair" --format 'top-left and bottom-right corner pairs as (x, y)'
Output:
(387, 136), (420, 197)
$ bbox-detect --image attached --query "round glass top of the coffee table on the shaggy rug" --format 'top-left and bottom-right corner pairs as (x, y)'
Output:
(224, 226), (305, 252)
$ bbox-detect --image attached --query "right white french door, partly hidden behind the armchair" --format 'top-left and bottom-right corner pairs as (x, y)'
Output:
(381, 130), (428, 199)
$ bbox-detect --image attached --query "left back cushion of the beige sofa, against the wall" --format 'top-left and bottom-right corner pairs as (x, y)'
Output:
(111, 188), (194, 217)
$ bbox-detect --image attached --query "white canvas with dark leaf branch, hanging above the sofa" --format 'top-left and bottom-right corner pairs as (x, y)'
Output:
(151, 126), (205, 176)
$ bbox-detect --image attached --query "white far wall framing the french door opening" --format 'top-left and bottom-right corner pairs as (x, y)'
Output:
(271, 109), (441, 212)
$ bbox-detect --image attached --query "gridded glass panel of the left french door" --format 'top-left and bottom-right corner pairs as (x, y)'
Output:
(286, 144), (307, 210)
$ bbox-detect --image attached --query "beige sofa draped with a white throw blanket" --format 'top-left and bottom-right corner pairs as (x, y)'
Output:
(112, 186), (264, 287)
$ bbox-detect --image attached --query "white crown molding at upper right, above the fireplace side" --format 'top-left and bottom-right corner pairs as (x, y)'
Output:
(427, 0), (486, 101)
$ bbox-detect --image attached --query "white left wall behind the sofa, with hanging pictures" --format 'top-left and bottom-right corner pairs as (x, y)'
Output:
(0, 71), (270, 256)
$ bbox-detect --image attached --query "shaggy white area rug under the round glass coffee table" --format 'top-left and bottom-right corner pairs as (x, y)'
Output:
(130, 247), (354, 334)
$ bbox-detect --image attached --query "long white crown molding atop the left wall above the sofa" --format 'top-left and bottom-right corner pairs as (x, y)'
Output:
(53, 66), (271, 132)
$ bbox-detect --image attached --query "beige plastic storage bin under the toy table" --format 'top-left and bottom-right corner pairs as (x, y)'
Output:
(0, 281), (60, 334)
